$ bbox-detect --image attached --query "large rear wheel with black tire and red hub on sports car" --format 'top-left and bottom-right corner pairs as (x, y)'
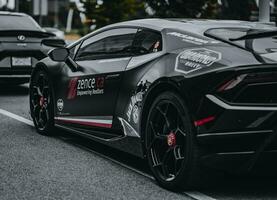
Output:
(145, 92), (200, 191)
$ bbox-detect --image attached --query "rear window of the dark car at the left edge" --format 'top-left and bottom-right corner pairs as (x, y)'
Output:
(0, 15), (42, 31)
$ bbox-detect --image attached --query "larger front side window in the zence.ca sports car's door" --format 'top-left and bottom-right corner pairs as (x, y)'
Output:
(76, 28), (137, 60)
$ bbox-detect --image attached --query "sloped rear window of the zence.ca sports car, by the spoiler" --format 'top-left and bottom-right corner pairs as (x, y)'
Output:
(205, 28), (277, 62)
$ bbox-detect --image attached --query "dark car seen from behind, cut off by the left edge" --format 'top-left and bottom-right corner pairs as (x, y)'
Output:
(0, 12), (65, 84)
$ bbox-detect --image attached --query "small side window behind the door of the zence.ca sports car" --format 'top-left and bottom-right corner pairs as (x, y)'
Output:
(133, 29), (163, 55)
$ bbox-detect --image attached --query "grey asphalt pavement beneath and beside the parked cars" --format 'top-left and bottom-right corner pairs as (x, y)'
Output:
(0, 85), (277, 200)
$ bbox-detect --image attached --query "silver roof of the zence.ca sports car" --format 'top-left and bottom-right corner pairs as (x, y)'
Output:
(108, 18), (276, 35)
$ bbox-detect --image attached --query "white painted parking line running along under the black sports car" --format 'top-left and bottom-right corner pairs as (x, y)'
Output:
(0, 109), (216, 200)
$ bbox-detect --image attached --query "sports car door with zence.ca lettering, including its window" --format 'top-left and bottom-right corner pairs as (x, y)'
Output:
(56, 28), (137, 129)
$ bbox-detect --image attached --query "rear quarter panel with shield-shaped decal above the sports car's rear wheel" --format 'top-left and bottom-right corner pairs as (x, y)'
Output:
(115, 30), (266, 139)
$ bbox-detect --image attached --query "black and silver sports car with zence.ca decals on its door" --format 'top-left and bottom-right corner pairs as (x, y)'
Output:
(30, 19), (277, 190)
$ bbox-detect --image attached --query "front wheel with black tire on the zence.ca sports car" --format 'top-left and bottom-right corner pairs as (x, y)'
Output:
(29, 70), (55, 135)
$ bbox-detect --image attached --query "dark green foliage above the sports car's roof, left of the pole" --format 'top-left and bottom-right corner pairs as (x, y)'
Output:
(81, 0), (255, 31)
